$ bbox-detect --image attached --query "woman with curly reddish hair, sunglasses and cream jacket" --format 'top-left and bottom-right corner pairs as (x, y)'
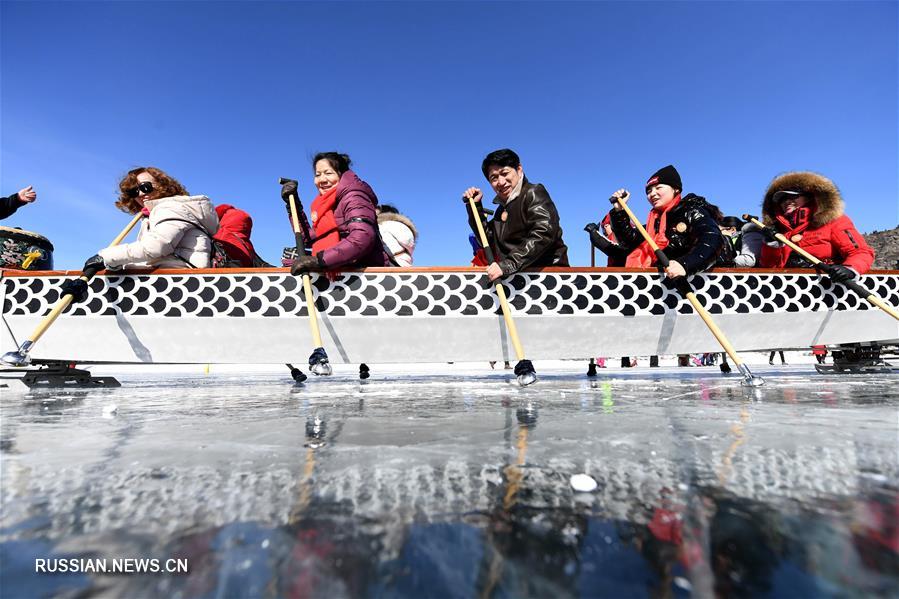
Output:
(84, 166), (219, 270)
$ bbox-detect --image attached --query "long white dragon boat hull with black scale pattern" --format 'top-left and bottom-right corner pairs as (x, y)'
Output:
(0, 267), (899, 364)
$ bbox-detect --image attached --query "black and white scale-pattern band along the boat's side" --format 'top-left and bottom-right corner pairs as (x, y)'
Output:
(2, 272), (899, 318)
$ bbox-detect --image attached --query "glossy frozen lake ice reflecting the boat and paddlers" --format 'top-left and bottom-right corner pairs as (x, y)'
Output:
(0, 362), (899, 598)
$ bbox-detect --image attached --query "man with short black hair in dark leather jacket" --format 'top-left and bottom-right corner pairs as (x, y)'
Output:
(462, 149), (568, 281)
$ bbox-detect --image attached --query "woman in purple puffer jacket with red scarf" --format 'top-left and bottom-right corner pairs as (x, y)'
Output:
(281, 152), (390, 275)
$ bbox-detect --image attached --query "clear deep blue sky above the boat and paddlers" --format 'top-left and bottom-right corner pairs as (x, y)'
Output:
(0, 0), (899, 268)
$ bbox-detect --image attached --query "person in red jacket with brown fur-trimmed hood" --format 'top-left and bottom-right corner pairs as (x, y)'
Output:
(759, 172), (874, 282)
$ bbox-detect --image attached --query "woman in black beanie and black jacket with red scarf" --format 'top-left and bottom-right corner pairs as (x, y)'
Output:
(609, 164), (724, 278)
